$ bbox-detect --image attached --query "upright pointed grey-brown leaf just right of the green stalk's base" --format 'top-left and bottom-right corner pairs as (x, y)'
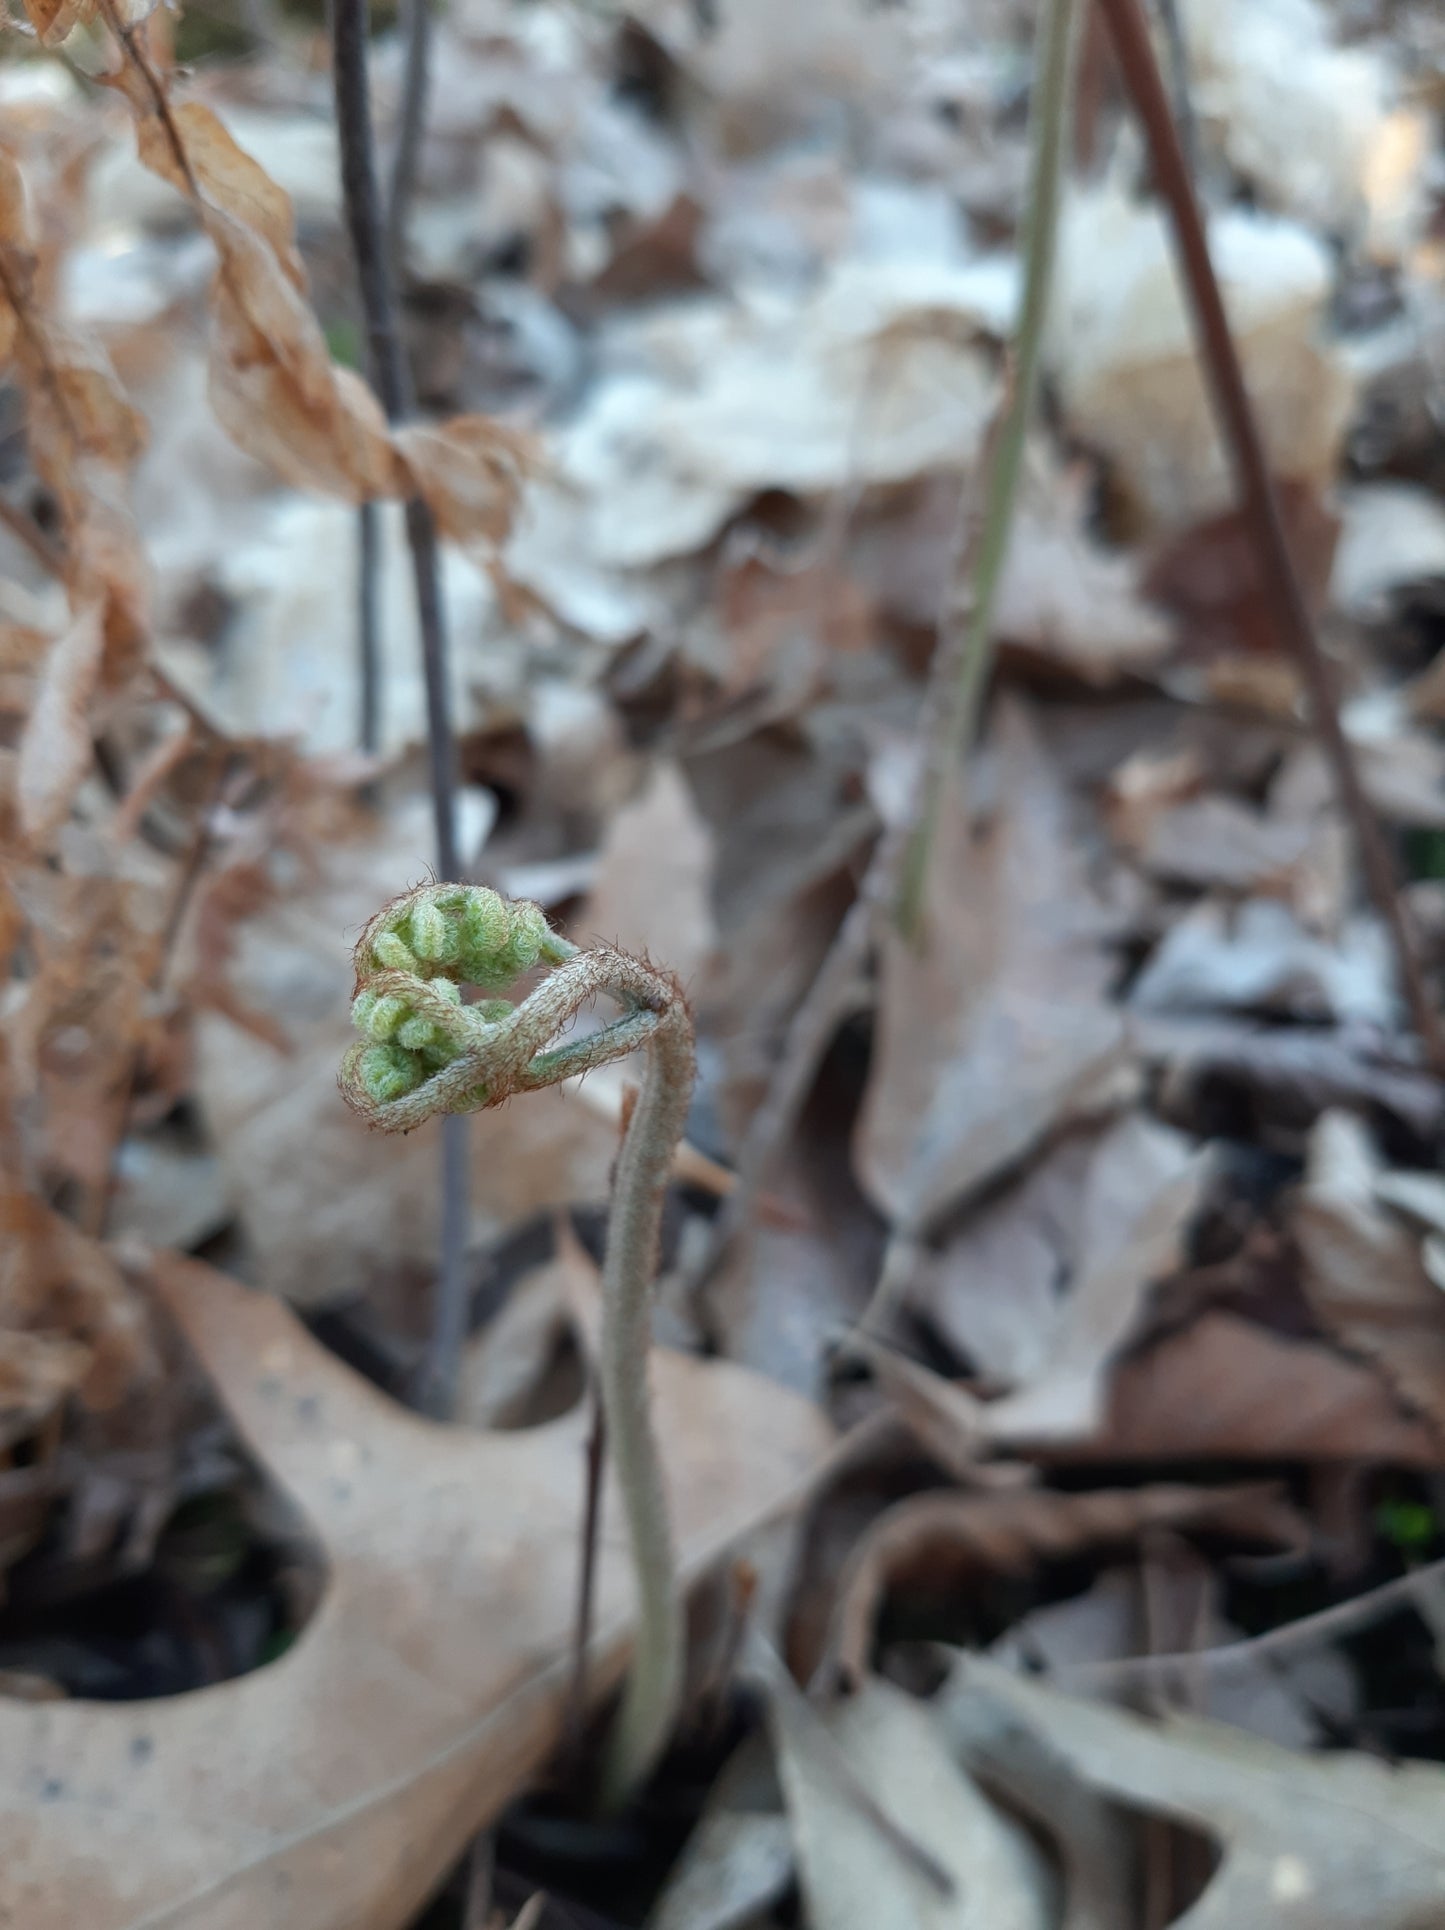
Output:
(855, 704), (1127, 1231)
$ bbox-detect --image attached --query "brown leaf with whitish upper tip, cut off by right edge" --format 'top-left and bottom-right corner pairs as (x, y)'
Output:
(1291, 1112), (1445, 1444)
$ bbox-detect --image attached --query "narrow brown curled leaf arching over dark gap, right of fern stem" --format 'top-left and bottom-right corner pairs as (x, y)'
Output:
(828, 1482), (1304, 1683)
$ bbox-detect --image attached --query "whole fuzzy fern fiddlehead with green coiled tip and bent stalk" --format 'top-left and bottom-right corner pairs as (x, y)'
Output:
(341, 884), (693, 1805)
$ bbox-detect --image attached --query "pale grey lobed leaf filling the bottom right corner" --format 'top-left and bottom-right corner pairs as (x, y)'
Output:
(953, 1660), (1445, 1930)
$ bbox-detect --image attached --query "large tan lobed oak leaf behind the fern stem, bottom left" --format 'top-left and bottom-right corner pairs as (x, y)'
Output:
(0, 1258), (830, 1930)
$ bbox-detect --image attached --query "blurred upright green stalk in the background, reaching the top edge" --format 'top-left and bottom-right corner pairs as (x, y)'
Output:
(895, 0), (1078, 940)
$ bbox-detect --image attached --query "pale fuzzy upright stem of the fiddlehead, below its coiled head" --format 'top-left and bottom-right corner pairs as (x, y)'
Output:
(600, 1000), (693, 1806)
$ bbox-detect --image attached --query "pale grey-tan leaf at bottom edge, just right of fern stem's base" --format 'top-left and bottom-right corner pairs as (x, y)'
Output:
(770, 1679), (1051, 1930)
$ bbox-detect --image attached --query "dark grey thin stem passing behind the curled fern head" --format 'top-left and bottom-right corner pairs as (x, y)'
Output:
(332, 0), (467, 1413)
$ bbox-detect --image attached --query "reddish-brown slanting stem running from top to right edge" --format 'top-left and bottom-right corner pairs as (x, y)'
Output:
(1098, 0), (1445, 1071)
